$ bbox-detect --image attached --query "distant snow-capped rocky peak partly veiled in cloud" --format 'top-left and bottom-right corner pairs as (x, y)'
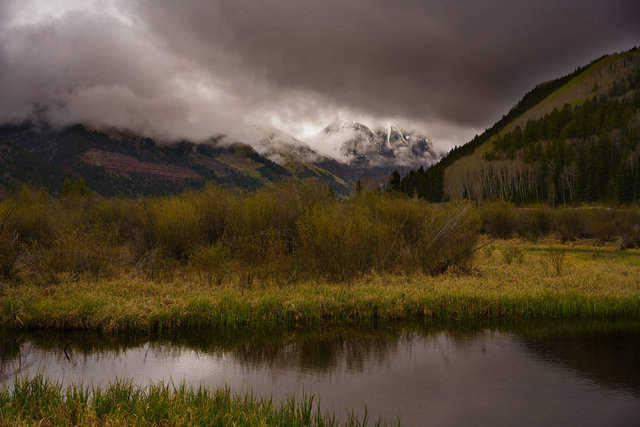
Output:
(312, 121), (440, 176)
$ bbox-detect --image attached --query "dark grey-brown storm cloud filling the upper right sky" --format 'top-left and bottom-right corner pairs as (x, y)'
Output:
(132, 0), (640, 126)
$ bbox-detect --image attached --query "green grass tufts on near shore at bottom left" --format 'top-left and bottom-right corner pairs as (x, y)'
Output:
(0, 377), (384, 426)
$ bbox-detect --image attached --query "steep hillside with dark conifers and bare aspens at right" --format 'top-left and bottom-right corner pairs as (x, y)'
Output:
(401, 48), (640, 204)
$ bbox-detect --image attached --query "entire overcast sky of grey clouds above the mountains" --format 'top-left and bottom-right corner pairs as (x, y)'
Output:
(0, 0), (640, 154)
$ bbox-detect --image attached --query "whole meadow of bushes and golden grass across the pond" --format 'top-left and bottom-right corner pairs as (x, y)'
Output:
(0, 182), (640, 331)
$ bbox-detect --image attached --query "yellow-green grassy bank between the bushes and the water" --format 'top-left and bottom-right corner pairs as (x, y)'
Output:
(0, 240), (640, 331)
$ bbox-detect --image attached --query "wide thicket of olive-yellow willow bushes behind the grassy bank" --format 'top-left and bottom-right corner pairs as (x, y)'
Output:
(0, 182), (480, 283)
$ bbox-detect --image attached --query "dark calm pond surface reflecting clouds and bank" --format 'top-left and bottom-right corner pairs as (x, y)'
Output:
(0, 321), (640, 426)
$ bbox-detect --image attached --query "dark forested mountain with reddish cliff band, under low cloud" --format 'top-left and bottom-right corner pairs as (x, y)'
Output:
(0, 123), (348, 196)
